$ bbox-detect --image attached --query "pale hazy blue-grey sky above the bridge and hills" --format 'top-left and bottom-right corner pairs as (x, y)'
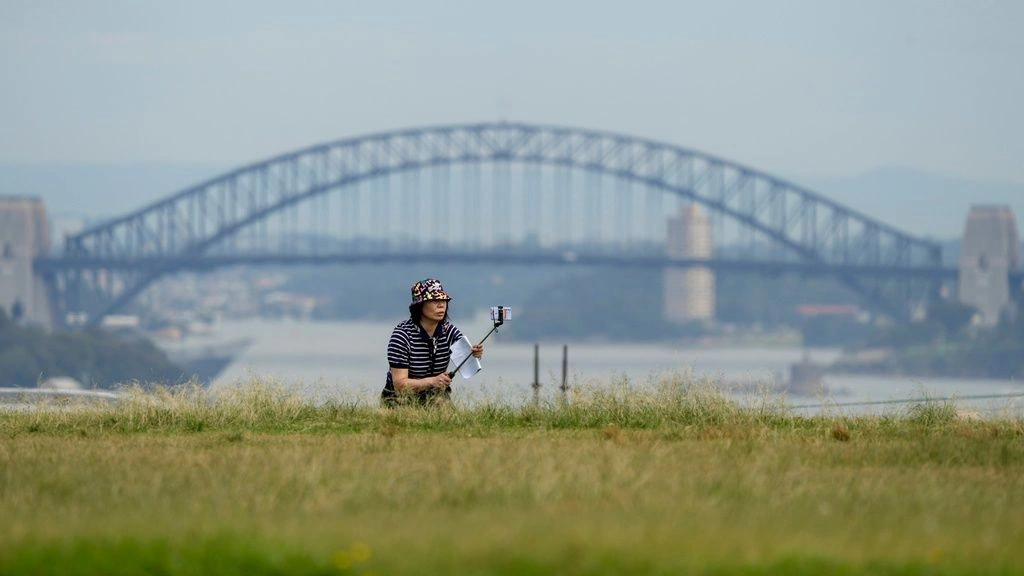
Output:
(0, 0), (1024, 182)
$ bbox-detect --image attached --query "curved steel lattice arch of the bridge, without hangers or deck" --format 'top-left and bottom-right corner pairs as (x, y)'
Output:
(63, 123), (941, 321)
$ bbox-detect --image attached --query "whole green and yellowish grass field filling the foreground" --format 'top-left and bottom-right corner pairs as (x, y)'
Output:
(0, 379), (1024, 575)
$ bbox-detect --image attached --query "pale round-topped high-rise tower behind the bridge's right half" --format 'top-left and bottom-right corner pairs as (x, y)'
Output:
(663, 204), (715, 324)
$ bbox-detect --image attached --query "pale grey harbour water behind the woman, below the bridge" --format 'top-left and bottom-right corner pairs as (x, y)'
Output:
(211, 317), (1024, 415)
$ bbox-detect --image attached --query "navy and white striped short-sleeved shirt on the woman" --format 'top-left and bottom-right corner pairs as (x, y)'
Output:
(381, 319), (462, 402)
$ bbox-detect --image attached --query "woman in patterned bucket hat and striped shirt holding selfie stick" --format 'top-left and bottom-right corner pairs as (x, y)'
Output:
(381, 278), (483, 406)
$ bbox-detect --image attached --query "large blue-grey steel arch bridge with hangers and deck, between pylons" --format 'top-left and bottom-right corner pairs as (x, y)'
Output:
(37, 123), (949, 324)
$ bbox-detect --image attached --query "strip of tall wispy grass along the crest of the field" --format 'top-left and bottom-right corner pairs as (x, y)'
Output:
(0, 375), (1024, 436)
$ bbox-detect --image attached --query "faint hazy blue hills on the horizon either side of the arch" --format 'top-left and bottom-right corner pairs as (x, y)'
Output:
(0, 164), (1024, 240)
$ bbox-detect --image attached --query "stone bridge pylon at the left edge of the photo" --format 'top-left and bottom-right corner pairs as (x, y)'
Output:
(0, 196), (52, 326)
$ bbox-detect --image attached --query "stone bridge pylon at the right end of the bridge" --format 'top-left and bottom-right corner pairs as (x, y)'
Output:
(958, 206), (1021, 326)
